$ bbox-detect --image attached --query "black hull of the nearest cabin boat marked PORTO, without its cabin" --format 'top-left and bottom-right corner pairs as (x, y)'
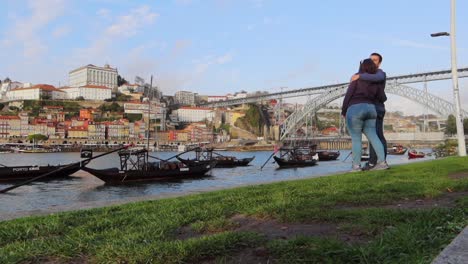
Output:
(82, 163), (215, 184)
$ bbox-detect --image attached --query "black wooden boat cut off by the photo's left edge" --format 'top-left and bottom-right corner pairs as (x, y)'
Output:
(0, 162), (87, 182)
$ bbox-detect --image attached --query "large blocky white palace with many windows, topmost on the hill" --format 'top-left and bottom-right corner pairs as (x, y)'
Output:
(68, 64), (118, 89)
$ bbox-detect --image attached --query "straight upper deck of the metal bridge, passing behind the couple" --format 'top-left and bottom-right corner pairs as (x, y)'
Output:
(199, 68), (468, 107)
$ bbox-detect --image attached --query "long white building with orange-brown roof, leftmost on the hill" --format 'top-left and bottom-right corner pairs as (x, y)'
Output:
(6, 84), (66, 100)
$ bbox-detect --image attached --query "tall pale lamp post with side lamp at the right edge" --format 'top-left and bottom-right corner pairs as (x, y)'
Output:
(431, 0), (466, 157)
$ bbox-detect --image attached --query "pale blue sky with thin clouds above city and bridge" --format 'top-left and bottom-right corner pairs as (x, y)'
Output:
(0, 0), (468, 114)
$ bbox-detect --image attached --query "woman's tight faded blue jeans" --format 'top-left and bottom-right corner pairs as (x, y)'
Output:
(346, 103), (385, 166)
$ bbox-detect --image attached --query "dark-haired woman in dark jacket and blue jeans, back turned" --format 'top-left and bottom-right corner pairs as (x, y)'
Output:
(341, 59), (388, 171)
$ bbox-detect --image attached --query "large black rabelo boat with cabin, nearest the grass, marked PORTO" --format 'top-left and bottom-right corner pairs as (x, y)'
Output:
(82, 149), (216, 184)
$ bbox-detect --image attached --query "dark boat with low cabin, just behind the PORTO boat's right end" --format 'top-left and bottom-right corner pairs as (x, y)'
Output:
(176, 148), (255, 168)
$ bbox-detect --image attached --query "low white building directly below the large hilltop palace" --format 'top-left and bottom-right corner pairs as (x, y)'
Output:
(61, 84), (112, 101)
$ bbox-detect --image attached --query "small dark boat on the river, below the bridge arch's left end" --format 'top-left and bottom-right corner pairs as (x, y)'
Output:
(273, 145), (319, 168)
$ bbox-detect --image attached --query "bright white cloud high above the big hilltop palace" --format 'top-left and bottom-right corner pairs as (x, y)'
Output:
(106, 6), (159, 37)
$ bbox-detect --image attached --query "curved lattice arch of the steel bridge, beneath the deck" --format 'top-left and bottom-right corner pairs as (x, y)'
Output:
(281, 83), (468, 140)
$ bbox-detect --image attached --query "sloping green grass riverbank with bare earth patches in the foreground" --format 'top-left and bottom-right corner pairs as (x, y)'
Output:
(0, 157), (468, 263)
